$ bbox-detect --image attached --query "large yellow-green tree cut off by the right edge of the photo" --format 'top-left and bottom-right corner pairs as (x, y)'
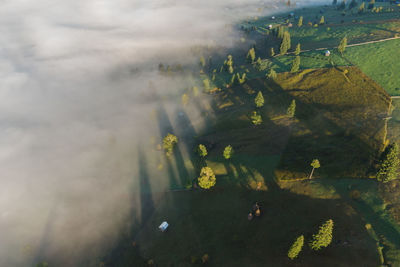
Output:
(376, 143), (400, 183)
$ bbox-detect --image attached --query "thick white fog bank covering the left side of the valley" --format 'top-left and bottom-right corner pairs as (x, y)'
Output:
(0, 0), (328, 266)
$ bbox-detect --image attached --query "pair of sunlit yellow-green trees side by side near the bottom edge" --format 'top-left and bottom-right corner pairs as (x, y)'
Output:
(288, 219), (333, 260)
